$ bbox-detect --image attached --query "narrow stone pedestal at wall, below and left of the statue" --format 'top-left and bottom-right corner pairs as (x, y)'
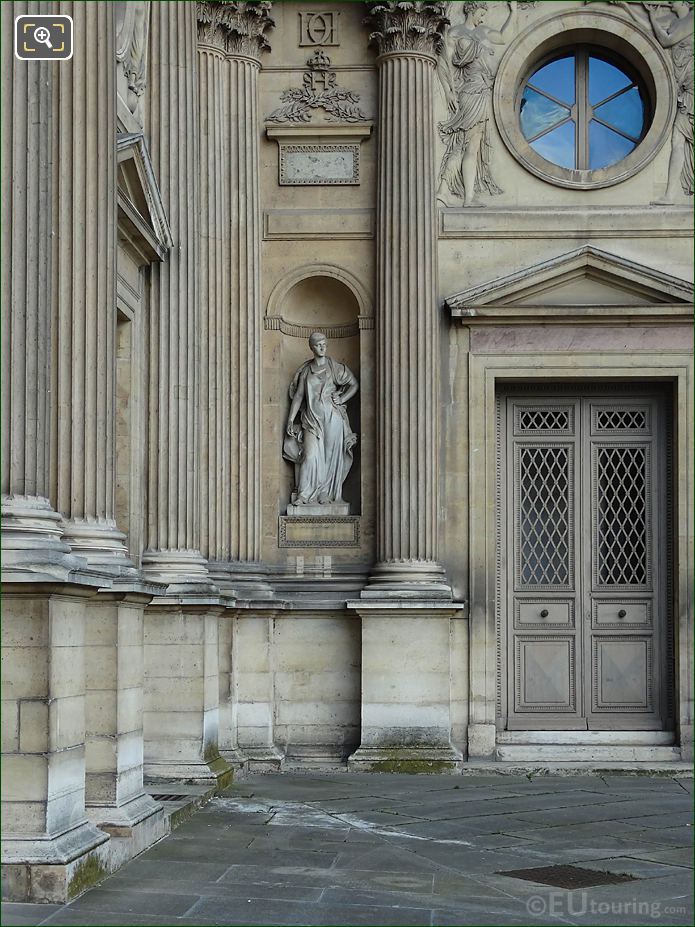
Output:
(232, 610), (282, 770)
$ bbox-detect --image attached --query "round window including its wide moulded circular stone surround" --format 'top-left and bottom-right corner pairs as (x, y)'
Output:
(493, 3), (676, 190)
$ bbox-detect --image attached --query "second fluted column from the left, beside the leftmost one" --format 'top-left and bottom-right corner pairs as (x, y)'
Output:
(53, 0), (130, 569)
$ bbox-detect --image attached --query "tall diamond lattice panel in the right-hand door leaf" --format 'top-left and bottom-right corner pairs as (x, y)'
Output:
(596, 447), (647, 586)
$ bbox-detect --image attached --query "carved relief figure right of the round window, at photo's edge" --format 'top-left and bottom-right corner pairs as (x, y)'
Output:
(615, 2), (695, 205)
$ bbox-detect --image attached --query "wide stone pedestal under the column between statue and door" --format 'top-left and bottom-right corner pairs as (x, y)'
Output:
(348, 601), (462, 773)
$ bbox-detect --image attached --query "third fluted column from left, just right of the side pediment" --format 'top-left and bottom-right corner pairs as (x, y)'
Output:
(143, 2), (210, 592)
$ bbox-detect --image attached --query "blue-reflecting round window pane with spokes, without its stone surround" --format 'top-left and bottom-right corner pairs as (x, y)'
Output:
(519, 48), (649, 171)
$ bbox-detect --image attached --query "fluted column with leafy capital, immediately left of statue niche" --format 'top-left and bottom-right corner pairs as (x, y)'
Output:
(198, 2), (272, 595)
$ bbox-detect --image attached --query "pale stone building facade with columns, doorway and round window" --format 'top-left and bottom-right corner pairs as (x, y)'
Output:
(1, 0), (695, 901)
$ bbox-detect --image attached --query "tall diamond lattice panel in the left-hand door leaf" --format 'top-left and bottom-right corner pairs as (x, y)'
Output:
(518, 447), (570, 586)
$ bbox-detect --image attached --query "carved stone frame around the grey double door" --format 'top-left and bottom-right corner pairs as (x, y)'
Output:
(468, 352), (695, 759)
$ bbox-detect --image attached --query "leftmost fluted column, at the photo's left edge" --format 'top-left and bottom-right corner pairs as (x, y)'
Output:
(0, 2), (76, 581)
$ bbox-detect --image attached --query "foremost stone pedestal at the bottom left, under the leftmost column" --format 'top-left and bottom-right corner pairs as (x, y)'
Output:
(2, 584), (110, 902)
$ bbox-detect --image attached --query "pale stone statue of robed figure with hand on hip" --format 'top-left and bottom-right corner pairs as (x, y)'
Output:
(283, 332), (358, 515)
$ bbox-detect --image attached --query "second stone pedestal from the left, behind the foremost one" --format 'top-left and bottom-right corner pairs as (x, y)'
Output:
(85, 587), (167, 869)
